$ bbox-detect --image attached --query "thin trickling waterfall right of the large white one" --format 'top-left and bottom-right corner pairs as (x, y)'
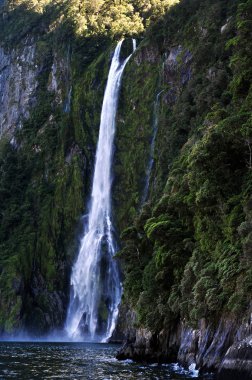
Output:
(141, 90), (164, 204)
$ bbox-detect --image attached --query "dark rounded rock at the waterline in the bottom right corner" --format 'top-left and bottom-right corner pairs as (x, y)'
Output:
(218, 335), (252, 380)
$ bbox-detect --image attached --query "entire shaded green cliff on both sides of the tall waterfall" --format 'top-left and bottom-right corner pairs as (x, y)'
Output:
(0, 0), (252, 376)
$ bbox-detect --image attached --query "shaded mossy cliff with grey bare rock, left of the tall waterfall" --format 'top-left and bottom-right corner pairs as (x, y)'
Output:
(0, 0), (111, 335)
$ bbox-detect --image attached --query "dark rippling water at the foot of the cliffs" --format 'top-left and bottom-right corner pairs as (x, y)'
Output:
(0, 342), (214, 380)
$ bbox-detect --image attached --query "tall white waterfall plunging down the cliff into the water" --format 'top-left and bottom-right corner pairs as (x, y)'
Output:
(66, 40), (136, 341)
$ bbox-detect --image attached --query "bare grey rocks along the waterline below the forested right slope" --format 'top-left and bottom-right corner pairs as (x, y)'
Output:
(117, 313), (252, 380)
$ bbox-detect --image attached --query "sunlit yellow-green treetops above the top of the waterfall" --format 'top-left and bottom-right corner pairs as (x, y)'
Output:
(0, 0), (177, 45)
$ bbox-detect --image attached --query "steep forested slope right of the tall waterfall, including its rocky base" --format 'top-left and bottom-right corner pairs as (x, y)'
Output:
(115, 1), (252, 370)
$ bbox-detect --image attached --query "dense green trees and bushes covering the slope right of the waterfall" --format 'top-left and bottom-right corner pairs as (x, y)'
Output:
(118, 1), (252, 331)
